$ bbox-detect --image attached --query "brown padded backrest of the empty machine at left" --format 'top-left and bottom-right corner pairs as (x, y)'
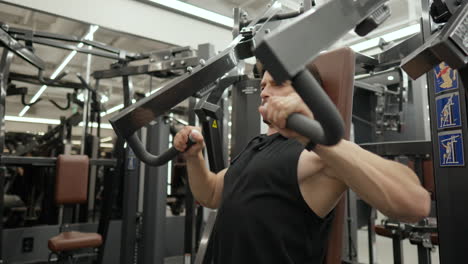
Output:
(55, 155), (89, 204)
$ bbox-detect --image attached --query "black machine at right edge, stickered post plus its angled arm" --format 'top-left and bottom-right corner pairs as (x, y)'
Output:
(401, 0), (468, 263)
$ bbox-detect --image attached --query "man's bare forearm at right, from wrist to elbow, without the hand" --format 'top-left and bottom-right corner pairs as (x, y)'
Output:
(315, 140), (429, 221)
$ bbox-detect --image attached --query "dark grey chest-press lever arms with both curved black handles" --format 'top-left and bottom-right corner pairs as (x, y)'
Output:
(109, 0), (390, 169)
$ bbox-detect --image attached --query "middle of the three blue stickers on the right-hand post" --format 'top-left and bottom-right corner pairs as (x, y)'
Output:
(436, 92), (461, 129)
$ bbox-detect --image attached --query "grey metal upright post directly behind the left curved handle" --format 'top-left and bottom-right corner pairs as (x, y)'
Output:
(138, 117), (170, 264)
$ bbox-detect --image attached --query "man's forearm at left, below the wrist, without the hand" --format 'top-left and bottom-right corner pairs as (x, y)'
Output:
(187, 152), (216, 208)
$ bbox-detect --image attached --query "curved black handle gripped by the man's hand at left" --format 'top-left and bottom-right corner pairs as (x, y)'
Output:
(127, 133), (196, 167)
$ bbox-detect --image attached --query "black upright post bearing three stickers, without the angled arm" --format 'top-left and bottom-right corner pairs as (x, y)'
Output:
(421, 0), (468, 263)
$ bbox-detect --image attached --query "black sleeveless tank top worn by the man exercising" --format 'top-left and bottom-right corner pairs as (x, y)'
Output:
(213, 134), (332, 264)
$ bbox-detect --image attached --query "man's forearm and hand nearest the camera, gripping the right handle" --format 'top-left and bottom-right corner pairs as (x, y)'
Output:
(259, 93), (430, 222)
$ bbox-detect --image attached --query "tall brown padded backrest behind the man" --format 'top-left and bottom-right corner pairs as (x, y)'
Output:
(312, 48), (355, 264)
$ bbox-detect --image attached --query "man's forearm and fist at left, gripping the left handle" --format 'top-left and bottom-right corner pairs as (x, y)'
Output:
(174, 126), (227, 208)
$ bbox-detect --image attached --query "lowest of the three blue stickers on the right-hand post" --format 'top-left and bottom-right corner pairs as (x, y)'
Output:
(439, 130), (465, 167)
